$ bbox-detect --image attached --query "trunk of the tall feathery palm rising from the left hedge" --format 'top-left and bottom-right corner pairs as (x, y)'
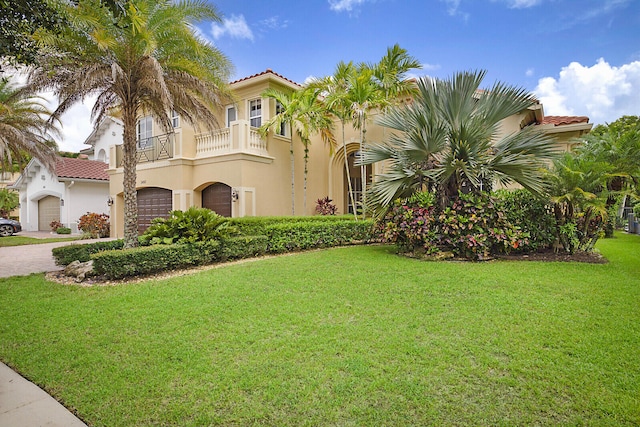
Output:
(122, 104), (138, 249)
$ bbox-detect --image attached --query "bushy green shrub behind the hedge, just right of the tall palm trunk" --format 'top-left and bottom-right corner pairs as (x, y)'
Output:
(140, 206), (236, 245)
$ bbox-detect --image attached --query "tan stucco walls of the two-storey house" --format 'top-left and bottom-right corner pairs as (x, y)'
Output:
(109, 75), (583, 236)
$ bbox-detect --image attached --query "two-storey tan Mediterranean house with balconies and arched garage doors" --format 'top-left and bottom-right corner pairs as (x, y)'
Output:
(104, 69), (592, 237)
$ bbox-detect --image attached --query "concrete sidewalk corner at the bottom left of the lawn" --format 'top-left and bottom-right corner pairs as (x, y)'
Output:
(0, 363), (86, 427)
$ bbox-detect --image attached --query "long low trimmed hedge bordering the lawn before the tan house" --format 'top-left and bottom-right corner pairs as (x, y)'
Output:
(60, 217), (373, 279)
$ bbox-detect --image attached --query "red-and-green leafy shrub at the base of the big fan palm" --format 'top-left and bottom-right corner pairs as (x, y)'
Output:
(377, 193), (529, 260)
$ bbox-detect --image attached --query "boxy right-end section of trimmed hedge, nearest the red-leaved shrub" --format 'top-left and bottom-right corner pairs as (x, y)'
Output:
(265, 221), (373, 253)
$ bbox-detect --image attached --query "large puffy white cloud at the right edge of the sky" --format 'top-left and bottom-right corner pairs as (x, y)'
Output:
(534, 58), (640, 123)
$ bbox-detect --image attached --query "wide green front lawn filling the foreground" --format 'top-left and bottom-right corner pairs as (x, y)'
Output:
(0, 234), (640, 426)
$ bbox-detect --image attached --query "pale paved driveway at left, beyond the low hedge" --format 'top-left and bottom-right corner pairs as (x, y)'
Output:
(0, 231), (111, 278)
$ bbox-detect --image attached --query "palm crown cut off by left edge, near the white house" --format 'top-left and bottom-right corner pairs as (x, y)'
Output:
(0, 78), (59, 170)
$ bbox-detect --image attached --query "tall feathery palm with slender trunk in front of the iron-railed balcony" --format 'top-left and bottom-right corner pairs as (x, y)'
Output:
(30, 0), (231, 248)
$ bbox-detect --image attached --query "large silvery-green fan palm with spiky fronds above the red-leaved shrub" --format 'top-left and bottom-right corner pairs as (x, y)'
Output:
(363, 71), (555, 214)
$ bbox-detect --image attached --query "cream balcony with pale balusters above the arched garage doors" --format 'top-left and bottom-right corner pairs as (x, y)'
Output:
(195, 120), (269, 159)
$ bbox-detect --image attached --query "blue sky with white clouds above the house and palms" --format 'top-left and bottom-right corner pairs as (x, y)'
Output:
(53, 0), (640, 150)
